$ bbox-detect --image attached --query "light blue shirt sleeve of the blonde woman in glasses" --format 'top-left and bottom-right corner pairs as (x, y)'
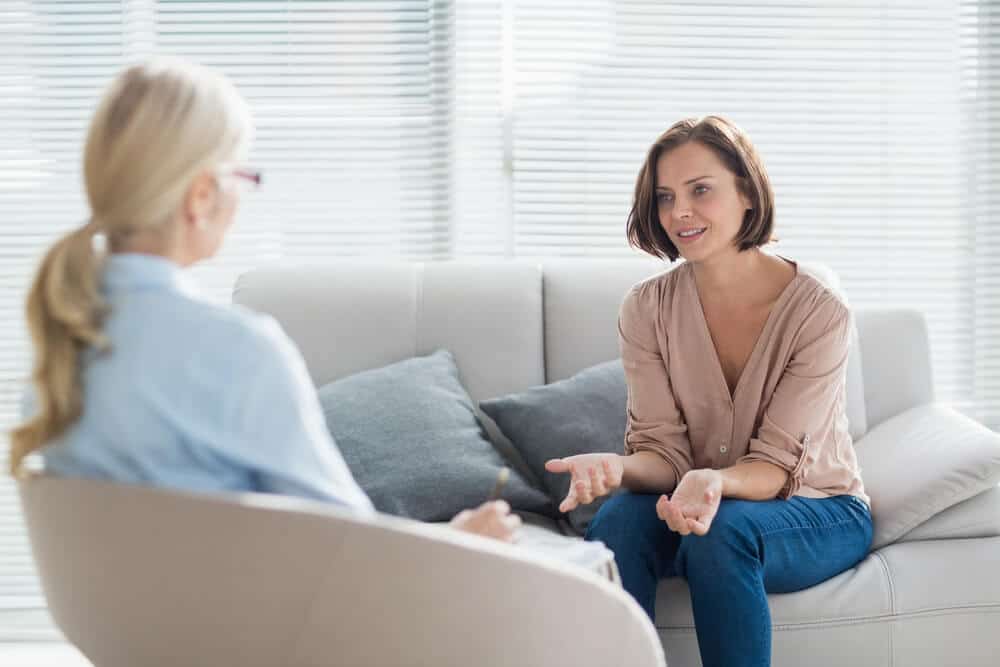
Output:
(229, 319), (375, 515)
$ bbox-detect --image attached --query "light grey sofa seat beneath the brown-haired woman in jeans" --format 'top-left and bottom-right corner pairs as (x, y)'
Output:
(656, 537), (1000, 667)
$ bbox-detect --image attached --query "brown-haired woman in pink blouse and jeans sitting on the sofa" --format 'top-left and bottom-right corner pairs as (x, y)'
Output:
(547, 116), (872, 667)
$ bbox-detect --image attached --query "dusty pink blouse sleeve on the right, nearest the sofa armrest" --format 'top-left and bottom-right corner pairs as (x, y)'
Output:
(737, 296), (851, 499)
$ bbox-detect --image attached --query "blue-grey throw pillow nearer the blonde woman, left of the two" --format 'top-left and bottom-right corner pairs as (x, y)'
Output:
(319, 350), (551, 521)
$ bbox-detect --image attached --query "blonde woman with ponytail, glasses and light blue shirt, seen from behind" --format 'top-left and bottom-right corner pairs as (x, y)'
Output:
(10, 60), (519, 541)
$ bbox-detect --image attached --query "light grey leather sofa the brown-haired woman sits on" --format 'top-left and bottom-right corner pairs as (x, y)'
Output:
(234, 259), (1000, 667)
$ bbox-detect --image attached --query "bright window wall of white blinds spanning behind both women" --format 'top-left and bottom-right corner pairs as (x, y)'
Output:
(0, 0), (1000, 641)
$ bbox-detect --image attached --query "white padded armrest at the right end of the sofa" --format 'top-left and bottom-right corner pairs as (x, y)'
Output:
(856, 404), (1000, 549)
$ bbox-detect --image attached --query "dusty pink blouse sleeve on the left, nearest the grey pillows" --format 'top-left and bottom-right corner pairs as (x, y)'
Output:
(618, 283), (694, 484)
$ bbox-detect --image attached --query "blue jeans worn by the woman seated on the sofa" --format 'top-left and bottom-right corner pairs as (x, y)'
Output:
(586, 492), (872, 667)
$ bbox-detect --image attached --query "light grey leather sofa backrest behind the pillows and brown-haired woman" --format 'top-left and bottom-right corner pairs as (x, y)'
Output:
(233, 259), (930, 438)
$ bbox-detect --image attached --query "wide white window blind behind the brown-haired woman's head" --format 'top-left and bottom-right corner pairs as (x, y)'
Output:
(504, 0), (980, 428)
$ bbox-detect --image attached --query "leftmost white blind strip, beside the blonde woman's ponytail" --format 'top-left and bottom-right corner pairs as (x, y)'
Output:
(0, 1), (134, 641)
